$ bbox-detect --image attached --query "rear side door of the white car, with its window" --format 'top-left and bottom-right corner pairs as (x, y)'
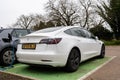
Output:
(70, 27), (92, 60)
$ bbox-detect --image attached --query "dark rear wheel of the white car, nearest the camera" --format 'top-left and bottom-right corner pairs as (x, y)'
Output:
(65, 48), (80, 72)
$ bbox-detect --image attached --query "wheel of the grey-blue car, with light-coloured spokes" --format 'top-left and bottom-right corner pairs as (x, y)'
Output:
(0, 48), (16, 66)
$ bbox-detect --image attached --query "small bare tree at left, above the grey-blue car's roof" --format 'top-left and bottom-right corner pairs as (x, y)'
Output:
(14, 15), (34, 29)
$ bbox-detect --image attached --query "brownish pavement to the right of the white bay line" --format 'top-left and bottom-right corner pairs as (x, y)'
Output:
(84, 46), (120, 80)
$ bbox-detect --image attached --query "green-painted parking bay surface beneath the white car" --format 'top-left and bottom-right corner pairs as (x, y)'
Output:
(6, 57), (110, 80)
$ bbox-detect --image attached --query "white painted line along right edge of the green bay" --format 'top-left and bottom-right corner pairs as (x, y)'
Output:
(77, 56), (117, 80)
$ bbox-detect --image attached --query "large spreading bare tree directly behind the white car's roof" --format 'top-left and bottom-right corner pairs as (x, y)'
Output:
(47, 0), (79, 26)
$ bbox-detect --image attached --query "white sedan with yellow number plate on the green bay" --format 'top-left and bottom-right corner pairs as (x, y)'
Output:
(16, 26), (105, 72)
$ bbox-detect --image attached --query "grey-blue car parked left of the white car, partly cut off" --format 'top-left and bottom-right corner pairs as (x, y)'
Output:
(0, 29), (30, 66)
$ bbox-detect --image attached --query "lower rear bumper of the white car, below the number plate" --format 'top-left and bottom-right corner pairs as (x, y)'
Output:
(17, 52), (67, 67)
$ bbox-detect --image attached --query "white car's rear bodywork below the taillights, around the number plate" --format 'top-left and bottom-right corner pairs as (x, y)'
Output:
(16, 44), (69, 67)
